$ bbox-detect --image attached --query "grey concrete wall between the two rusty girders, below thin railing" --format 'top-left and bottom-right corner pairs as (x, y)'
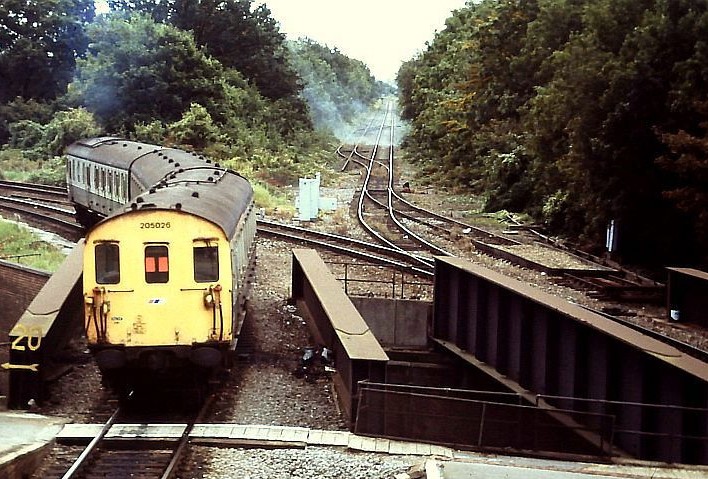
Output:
(350, 296), (433, 348)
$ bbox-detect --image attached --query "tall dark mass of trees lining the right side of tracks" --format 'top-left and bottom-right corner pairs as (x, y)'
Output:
(397, 0), (708, 266)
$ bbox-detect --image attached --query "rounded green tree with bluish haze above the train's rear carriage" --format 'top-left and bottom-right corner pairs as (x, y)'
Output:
(68, 14), (231, 131)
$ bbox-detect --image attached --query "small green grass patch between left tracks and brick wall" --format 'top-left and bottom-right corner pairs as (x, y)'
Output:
(0, 219), (66, 272)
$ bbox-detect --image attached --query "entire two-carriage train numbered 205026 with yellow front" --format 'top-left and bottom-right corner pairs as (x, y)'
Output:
(65, 137), (256, 394)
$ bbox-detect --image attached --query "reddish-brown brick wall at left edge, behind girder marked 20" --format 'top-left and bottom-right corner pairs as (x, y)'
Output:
(0, 260), (50, 404)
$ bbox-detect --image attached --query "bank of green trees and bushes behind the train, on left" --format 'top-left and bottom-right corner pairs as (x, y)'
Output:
(0, 0), (388, 193)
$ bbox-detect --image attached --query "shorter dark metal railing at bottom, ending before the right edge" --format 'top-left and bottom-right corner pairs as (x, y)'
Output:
(355, 381), (614, 456)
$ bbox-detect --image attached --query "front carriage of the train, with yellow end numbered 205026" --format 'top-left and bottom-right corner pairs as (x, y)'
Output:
(75, 140), (256, 392)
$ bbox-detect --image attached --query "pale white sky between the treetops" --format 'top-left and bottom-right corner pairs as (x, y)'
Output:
(262, 0), (466, 82)
